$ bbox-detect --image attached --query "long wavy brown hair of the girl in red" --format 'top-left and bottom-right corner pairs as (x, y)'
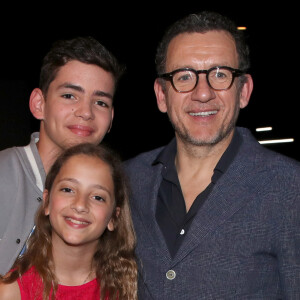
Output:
(1, 144), (137, 300)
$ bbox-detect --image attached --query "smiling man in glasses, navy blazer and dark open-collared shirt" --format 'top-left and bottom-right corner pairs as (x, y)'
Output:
(126, 12), (300, 300)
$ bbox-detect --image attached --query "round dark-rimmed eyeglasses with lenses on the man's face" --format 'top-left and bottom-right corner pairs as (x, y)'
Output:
(158, 66), (246, 93)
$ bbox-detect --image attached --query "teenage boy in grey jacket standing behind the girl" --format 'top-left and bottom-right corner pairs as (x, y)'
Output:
(0, 37), (122, 274)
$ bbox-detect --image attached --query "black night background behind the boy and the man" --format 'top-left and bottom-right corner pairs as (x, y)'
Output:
(0, 1), (300, 160)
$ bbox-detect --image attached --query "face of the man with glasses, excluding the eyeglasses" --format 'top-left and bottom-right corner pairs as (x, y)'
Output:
(155, 31), (252, 145)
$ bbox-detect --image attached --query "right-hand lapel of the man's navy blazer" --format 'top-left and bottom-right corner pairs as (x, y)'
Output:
(173, 151), (272, 264)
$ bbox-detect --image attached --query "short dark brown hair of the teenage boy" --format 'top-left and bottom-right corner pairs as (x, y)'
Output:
(39, 37), (123, 97)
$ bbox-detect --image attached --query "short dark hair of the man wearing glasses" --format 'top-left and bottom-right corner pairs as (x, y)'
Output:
(155, 11), (250, 74)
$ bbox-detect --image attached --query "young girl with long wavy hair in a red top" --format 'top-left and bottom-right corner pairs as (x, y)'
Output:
(0, 144), (137, 300)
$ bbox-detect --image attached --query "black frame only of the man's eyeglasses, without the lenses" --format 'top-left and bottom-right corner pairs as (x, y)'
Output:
(158, 66), (247, 93)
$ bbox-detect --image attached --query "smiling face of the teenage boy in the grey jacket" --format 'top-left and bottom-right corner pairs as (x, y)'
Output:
(35, 60), (115, 149)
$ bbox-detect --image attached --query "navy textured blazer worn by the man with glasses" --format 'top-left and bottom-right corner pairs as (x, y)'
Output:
(126, 128), (300, 300)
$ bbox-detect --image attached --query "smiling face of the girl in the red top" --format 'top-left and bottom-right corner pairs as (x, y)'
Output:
(44, 154), (115, 248)
